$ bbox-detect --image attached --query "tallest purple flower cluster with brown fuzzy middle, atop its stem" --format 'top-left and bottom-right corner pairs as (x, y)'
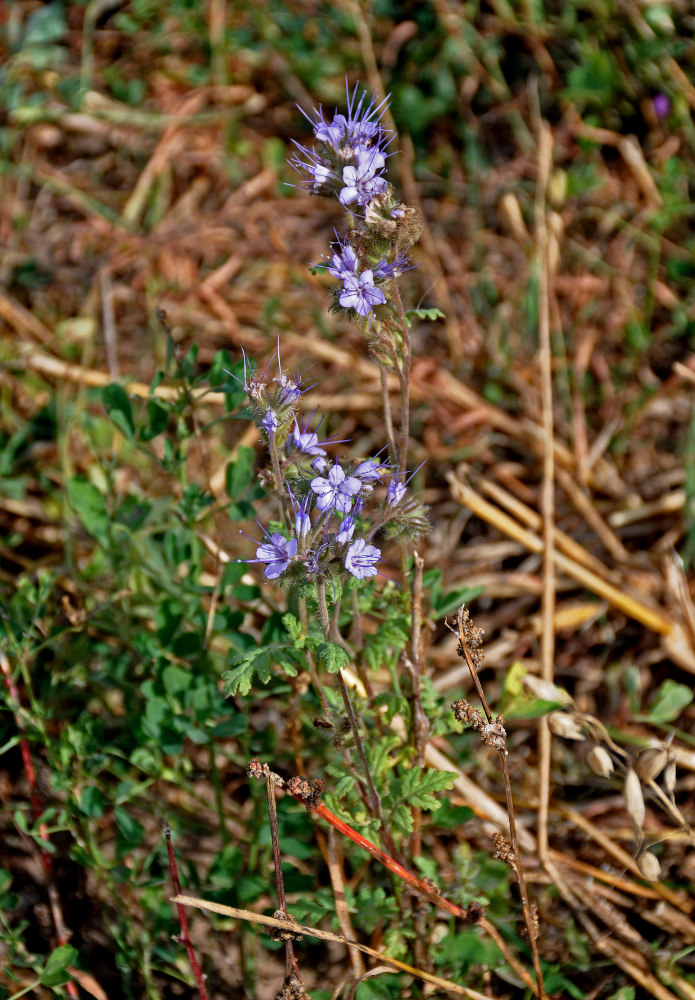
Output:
(291, 88), (421, 324)
